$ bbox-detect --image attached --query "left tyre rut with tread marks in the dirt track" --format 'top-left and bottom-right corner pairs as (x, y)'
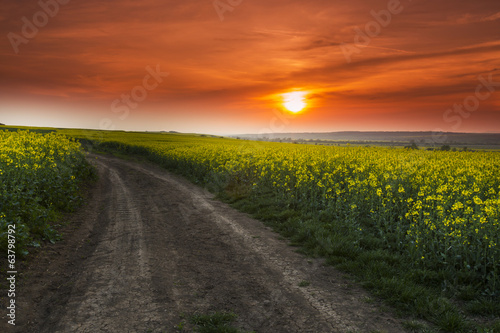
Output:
(46, 165), (160, 332)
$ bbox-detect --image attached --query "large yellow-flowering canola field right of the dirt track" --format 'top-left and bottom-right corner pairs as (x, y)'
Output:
(73, 132), (500, 296)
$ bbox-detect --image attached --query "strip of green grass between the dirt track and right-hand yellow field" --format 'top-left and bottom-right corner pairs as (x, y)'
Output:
(224, 192), (500, 333)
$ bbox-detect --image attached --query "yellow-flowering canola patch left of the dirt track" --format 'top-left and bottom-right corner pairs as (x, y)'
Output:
(0, 131), (92, 254)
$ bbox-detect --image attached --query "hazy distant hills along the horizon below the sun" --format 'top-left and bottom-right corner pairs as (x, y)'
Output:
(233, 131), (500, 148)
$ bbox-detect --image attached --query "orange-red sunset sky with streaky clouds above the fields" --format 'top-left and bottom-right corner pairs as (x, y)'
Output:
(0, 0), (500, 134)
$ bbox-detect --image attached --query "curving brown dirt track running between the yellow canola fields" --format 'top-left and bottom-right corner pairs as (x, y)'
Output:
(0, 156), (404, 333)
